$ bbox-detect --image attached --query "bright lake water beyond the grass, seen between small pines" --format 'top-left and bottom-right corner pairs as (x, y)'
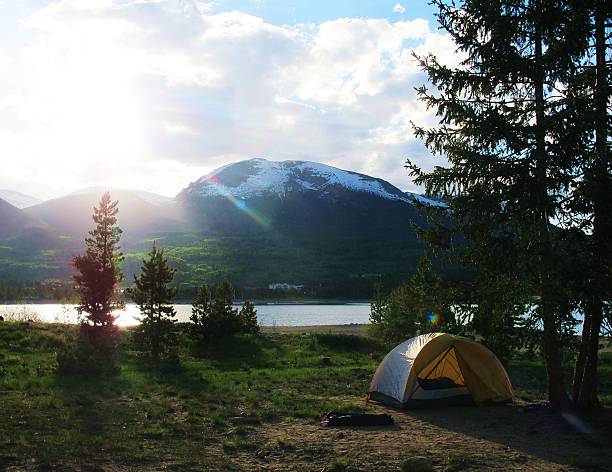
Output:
(0, 303), (370, 326)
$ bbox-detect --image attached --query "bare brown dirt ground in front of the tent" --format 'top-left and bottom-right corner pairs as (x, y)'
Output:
(232, 399), (612, 471)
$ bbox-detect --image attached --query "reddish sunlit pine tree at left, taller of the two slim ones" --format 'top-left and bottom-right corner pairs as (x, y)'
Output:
(73, 192), (124, 350)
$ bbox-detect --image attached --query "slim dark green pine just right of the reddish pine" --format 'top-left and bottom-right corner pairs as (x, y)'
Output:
(129, 244), (177, 362)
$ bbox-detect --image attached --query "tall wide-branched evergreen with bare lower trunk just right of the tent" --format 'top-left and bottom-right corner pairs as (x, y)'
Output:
(408, 0), (582, 408)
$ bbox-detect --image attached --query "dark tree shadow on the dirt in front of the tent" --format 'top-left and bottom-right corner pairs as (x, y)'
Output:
(396, 404), (612, 470)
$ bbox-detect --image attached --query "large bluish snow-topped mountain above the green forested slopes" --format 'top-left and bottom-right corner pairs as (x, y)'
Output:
(175, 159), (424, 241)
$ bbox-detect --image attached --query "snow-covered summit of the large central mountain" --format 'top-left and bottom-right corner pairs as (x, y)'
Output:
(179, 159), (411, 202)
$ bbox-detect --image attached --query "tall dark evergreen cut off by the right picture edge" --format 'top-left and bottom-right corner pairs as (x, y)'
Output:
(569, 0), (612, 409)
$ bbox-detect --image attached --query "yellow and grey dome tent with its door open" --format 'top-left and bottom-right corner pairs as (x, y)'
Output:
(368, 333), (512, 408)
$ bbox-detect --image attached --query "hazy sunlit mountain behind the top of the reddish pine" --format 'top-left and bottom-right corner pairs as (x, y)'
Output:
(24, 187), (188, 240)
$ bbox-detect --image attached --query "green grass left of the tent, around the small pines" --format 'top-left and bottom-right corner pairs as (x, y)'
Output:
(0, 323), (382, 470)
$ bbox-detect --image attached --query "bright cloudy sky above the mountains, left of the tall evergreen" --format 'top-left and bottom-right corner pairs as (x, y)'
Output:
(0, 0), (457, 199)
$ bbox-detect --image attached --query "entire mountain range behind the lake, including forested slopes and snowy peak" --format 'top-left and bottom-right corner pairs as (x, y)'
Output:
(0, 159), (444, 296)
